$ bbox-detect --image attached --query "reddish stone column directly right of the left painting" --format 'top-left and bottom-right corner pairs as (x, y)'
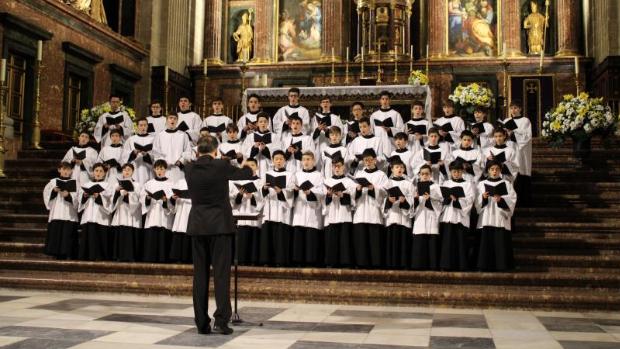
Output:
(321, 0), (346, 62)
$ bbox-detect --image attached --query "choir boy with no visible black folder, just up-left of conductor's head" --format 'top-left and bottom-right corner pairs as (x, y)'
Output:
(153, 114), (192, 181)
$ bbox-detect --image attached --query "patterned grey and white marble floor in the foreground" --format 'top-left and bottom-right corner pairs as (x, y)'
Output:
(0, 289), (620, 349)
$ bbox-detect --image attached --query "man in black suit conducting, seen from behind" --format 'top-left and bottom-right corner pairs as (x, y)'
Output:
(185, 136), (252, 334)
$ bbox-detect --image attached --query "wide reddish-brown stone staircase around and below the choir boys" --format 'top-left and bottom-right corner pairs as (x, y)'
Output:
(0, 140), (620, 310)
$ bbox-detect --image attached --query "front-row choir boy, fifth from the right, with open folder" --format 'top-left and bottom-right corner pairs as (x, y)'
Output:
(352, 148), (388, 268)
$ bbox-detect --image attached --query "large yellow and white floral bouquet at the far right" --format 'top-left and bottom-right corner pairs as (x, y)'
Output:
(541, 92), (620, 146)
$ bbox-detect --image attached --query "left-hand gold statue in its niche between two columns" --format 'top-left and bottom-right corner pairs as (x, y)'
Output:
(226, 1), (256, 63)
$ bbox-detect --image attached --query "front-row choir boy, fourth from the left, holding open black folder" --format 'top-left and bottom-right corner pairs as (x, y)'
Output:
(140, 160), (174, 263)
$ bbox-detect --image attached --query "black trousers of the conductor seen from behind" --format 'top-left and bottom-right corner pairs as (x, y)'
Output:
(192, 235), (233, 331)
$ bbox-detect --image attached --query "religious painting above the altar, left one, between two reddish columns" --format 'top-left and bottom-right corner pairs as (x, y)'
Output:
(277, 0), (323, 62)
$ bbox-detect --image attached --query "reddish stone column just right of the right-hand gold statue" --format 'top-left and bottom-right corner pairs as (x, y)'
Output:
(555, 0), (581, 56)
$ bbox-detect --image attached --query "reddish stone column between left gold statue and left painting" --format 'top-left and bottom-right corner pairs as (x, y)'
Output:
(252, 0), (277, 64)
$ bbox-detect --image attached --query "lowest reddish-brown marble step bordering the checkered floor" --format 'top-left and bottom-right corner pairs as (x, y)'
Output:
(0, 270), (620, 310)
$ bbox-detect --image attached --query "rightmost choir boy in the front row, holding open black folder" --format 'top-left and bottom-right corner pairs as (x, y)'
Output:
(476, 161), (517, 271)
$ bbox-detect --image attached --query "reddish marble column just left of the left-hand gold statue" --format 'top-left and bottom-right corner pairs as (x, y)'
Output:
(204, 0), (224, 64)
